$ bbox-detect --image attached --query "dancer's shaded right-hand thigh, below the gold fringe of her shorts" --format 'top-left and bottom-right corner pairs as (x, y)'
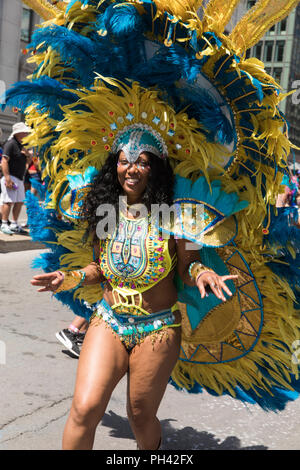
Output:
(127, 318), (181, 419)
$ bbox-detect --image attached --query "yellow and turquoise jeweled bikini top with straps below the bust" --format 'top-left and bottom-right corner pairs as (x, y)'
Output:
(99, 214), (177, 314)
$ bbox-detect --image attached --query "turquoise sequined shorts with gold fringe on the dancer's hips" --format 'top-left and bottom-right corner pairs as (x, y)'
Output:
(93, 299), (181, 351)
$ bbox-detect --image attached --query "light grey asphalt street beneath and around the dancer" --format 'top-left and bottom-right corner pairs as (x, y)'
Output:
(0, 250), (300, 450)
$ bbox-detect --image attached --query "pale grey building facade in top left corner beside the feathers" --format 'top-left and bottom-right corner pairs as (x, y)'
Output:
(0, 0), (40, 141)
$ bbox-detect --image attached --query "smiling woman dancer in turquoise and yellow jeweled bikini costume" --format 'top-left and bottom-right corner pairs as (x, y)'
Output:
(32, 144), (237, 449)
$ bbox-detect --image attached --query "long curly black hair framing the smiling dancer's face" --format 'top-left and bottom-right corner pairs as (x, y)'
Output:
(81, 152), (174, 240)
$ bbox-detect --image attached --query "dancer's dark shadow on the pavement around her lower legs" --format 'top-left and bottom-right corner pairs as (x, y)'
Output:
(101, 411), (268, 450)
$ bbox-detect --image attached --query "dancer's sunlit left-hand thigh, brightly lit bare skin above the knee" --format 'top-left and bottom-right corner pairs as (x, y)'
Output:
(73, 318), (128, 415)
